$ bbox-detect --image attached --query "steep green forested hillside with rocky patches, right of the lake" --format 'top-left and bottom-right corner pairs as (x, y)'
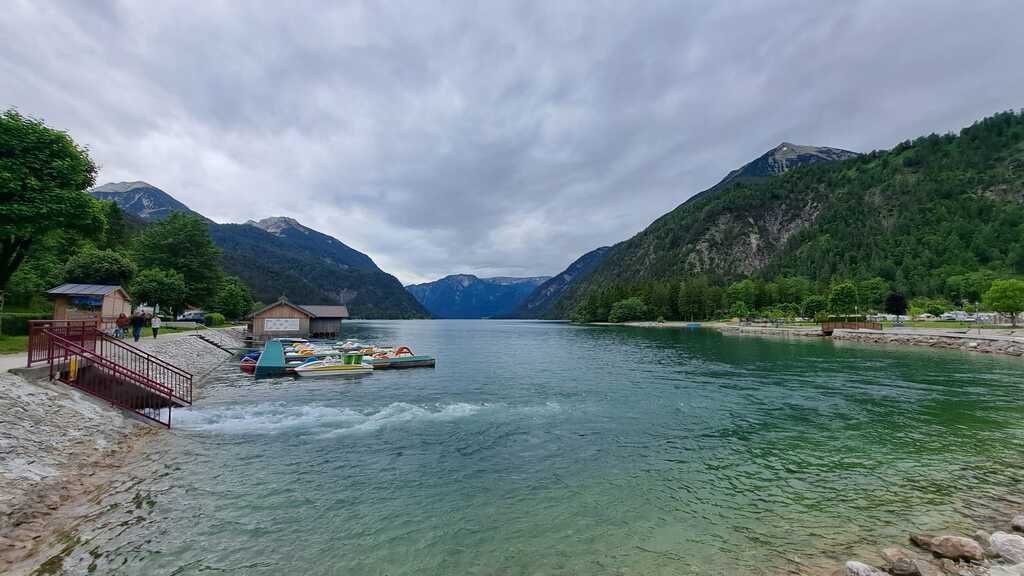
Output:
(553, 112), (1024, 318)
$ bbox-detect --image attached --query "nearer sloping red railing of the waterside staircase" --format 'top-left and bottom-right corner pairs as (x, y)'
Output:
(48, 327), (180, 427)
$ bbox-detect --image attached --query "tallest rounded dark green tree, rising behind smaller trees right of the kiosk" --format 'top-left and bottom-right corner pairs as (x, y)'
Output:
(134, 212), (221, 305)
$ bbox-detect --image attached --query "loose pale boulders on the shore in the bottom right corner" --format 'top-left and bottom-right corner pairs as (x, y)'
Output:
(833, 515), (1024, 576)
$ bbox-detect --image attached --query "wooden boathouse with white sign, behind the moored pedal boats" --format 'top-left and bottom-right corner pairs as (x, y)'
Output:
(252, 297), (348, 340)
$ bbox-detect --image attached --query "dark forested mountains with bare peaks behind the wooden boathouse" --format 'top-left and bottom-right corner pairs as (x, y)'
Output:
(90, 181), (429, 318)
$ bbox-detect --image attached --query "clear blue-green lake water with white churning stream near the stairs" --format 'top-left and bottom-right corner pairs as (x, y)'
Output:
(36, 321), (1024, 575)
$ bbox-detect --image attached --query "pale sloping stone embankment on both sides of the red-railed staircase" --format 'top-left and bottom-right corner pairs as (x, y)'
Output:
(0, 329), (241, 574)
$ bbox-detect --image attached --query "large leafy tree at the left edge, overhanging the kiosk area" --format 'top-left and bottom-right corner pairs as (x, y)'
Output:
(0, 110), (103, 289)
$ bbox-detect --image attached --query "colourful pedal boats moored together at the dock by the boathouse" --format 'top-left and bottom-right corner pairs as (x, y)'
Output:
(240, 338), (435, 378)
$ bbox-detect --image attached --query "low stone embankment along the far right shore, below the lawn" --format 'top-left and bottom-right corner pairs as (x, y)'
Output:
(833, 329), (1024, 357)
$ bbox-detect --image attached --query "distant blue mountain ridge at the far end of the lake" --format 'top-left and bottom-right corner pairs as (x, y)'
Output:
(406, 274), (548, 319)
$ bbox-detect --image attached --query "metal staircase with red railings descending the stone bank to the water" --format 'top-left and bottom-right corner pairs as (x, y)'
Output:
(29, 320), (193, 427)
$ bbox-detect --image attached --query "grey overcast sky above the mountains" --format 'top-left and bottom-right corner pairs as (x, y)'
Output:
(0, 0), (1024, 283)
